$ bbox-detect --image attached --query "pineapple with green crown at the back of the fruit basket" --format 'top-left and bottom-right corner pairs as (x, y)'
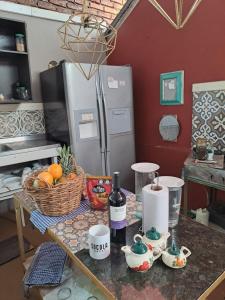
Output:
(58, 145), (76, 175)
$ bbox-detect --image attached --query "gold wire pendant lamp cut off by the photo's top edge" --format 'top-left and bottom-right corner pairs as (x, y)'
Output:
(148, 0), (202, 29)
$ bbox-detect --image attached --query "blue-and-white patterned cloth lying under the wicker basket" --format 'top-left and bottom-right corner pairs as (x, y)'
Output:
(30, 199), (90, 234)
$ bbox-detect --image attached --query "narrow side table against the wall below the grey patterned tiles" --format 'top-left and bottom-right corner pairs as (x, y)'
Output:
(184, 154), (225, 215)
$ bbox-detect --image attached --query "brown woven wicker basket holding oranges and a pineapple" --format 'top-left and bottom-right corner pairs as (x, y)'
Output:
(23, 166), (84, 216)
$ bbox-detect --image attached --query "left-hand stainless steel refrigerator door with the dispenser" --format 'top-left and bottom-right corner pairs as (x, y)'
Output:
(63, 63), (104, 175)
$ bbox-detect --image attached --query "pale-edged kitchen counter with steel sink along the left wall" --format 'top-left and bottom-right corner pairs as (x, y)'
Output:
(0, 138), (60, 167)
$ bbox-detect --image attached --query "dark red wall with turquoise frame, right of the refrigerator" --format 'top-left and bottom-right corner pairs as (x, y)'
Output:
(109, 0), (225, 208)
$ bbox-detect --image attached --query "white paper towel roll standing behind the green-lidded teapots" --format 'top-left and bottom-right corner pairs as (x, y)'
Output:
(142, 184), (169, 233)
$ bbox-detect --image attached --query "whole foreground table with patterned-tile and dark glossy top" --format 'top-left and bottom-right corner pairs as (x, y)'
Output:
(14, 192), (225, 300)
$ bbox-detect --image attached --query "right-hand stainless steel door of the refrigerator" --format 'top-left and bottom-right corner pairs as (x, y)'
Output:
(100, 66), (135, 191)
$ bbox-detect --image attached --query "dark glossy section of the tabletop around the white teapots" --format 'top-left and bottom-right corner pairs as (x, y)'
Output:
(76, 216), (225, 300)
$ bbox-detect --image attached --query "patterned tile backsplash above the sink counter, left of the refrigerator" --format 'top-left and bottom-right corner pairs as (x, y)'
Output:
(0, 110), (45, 139)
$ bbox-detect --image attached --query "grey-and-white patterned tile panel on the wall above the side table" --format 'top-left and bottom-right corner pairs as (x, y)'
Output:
(192, 82), (225, 152)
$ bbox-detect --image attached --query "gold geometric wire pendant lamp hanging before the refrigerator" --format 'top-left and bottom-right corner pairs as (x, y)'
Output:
(58, 1), (117, 80)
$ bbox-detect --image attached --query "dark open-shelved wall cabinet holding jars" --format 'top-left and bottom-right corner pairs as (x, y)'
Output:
(0, 18), (32, 103)
